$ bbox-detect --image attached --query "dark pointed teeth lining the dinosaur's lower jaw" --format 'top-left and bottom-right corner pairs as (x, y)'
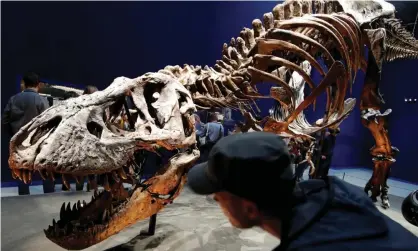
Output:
(44, 191), (127, 236)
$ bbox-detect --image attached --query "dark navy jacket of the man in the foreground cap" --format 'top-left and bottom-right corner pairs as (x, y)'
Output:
(274, 177), (418, 251)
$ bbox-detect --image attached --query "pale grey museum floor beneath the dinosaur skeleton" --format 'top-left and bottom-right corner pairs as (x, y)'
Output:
(1, 169), (418, 251)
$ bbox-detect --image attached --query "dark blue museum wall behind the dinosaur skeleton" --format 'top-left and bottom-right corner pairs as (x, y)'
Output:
(1, 2), (418, 182)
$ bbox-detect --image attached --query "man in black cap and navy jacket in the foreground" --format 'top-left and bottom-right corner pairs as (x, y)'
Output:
(188, 132), (418, 251)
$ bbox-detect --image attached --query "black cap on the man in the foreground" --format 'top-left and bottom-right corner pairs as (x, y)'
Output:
(188, 132), (295, 210)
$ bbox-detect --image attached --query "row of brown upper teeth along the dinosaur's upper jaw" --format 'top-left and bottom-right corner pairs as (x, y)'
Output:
(12, 165), (134, 191)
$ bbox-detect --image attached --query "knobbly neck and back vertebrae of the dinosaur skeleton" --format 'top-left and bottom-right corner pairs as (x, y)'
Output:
(154, 0), (341, 109)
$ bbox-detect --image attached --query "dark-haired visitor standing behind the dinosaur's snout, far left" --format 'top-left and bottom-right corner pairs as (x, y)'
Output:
(2, 72), (55, 195)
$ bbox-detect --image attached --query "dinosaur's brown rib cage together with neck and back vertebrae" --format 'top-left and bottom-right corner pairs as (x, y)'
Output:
(160, 1), (362, 136)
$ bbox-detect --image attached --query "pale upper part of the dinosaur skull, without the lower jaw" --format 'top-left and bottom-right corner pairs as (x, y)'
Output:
(9, 73), (195, 175)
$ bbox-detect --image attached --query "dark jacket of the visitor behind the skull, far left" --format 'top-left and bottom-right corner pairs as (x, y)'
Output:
(2, 89), (49, 135)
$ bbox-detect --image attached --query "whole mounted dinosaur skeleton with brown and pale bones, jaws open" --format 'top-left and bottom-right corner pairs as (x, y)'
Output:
(9, 0), (418, 250)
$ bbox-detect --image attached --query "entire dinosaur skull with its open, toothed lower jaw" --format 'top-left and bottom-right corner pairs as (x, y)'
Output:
(9, 73), (199, 250)
